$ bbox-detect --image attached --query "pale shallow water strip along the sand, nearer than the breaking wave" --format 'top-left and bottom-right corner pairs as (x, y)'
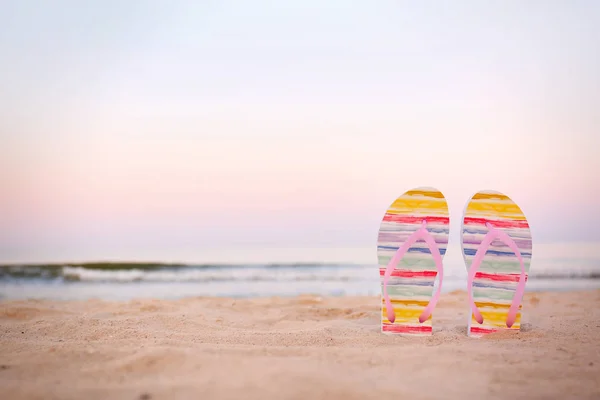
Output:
(0, 278), (600, 303)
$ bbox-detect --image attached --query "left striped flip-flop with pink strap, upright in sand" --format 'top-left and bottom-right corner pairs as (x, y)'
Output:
(377, 187), (450, 336)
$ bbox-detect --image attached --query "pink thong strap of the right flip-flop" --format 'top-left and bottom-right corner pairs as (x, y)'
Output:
(467, 222), (527, 328)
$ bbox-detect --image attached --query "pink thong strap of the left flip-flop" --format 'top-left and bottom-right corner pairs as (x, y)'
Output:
(383, 219), (444, 323)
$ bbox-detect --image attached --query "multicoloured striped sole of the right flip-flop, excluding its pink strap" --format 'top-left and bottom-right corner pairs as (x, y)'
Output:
(462, 191), (532, 337)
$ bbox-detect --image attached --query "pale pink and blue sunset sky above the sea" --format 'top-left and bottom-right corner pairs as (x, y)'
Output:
(0, 0), (600, 262)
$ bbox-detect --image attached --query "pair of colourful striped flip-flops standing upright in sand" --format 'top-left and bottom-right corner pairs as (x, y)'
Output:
(377, 188), (532, 337)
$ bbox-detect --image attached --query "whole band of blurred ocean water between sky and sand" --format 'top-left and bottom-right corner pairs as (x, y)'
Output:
(0, 244), (600, 300)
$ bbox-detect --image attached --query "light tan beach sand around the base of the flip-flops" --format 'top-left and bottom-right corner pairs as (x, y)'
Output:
(0, 290), (600, 400)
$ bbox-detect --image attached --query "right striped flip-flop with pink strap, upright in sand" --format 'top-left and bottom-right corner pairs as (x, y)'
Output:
(461, 190), (532, 337)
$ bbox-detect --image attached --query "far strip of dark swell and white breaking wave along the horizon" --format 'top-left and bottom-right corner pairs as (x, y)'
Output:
(0, 263), (600, 283)
